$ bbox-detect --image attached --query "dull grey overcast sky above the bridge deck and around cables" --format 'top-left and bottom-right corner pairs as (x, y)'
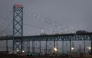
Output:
(0, 0), (92, 53)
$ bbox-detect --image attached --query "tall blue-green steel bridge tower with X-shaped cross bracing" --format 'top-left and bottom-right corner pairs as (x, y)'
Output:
(13, 4), (23, 53)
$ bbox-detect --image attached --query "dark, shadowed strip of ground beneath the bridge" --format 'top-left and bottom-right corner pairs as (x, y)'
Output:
(0, 54), (92, 58)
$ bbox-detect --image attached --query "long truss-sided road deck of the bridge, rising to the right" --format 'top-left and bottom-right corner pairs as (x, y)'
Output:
(0, 32), (92, 41)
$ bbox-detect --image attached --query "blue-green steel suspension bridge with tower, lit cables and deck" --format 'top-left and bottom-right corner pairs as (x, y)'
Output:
(0, 4), (92, 54)
